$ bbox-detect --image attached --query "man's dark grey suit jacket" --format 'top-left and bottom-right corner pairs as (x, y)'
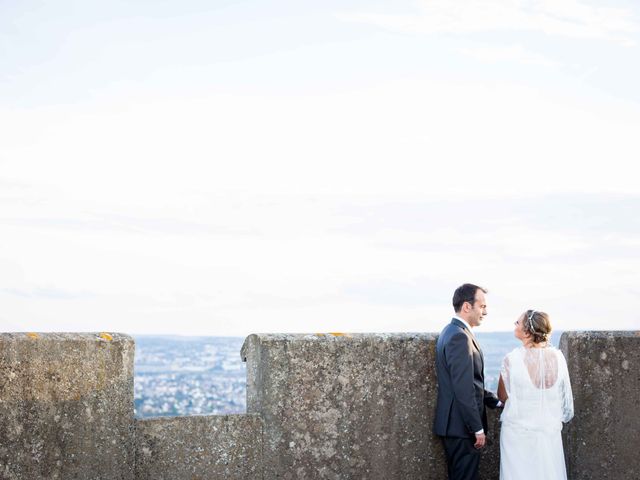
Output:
(433, 318), (498, 438)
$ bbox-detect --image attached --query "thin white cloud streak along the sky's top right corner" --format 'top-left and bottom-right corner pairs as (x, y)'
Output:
(337, 0), (638, 46)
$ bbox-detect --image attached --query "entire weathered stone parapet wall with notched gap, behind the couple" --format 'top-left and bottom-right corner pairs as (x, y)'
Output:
(0, 332), (640, 480)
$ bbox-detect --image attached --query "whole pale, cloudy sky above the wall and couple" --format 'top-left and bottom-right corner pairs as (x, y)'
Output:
(0, 0), (640, 336)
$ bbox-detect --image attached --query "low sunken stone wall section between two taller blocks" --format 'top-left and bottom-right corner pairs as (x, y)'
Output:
(135, 415), (262, 480)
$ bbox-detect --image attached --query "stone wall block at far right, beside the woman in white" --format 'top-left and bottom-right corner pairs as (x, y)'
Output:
(560, 331), (640, 480)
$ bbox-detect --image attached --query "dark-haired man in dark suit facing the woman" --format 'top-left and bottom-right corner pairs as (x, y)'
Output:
(434, 283), (502, 480)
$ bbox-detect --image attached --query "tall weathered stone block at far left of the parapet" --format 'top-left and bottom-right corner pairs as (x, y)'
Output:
(0, 333), (134, 480)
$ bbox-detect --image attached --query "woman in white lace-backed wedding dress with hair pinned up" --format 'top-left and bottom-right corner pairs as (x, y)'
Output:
(498, 310), (573, 480)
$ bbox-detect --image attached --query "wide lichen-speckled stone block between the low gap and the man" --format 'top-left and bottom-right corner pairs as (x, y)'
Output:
(242, 333), (458, 480)
